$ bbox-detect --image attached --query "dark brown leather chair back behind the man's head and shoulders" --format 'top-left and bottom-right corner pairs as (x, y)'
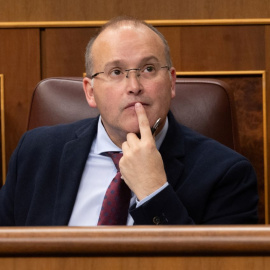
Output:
(28, 78), (238, 150)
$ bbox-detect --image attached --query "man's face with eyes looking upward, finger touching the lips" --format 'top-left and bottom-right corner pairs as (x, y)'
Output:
(84, 25), (175, 145)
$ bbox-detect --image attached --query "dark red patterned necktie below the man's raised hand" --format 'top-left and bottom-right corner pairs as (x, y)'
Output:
(98, 152), (131, 225)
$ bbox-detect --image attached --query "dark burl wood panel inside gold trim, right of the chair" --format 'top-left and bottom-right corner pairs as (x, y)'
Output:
(178, 74), (264, 224)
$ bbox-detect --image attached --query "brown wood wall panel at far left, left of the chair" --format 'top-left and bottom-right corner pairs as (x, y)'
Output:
(0, 29), (40, 179)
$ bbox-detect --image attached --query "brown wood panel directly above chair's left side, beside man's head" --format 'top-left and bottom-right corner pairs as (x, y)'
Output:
(41, 28), (97, 78)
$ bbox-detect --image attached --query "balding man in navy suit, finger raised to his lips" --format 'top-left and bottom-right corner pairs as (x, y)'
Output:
(0, 18), (258, 226)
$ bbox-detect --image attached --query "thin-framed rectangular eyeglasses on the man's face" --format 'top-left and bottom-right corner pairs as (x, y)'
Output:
(90, 63), (170, 82)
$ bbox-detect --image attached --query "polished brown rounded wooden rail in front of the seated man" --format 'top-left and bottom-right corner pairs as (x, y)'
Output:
(0, 225), (270, 255)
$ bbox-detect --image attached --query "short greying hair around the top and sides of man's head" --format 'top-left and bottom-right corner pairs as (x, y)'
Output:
(85, 16), (172, 77)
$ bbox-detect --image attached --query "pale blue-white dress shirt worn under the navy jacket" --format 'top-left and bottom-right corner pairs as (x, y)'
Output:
(68, 117), (168, 226)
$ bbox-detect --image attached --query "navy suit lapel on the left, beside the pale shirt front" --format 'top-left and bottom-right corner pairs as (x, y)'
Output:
(53, 118), (98, 225)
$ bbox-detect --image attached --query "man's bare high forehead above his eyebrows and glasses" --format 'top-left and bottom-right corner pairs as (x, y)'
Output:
(92, 25), (165, 67)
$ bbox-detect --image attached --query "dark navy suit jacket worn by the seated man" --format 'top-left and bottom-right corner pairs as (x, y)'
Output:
(0, 113), (258, 226)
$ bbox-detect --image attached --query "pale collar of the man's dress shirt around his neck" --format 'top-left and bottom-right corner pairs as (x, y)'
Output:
(94, 116), (169, 154)
